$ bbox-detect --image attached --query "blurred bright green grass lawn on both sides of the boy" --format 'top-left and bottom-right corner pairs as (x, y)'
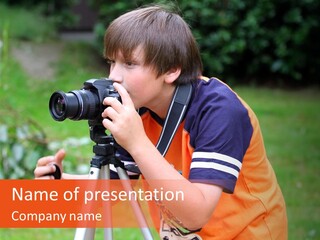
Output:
(0, 2), (320, 240)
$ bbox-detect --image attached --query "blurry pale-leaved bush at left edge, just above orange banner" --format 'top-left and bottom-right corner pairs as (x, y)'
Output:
(0, 107), (49, 179)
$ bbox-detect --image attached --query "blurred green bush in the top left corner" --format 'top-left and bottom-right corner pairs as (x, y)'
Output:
(0, 0), (78, 38)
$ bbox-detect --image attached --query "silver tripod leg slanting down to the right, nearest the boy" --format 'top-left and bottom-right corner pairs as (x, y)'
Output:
(116, 167), (153, 240)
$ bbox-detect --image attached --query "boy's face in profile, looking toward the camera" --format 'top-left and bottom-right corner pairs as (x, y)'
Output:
(109, 47), (174, 110)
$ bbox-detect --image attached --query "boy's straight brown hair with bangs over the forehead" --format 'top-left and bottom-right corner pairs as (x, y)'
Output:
(104, 5), (202, 84)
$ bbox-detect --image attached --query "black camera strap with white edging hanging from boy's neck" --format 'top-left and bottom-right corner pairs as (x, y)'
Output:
(125, 83), (192, 173)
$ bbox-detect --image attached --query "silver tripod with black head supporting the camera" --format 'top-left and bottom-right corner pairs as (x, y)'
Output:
(74, 120), (153, 240)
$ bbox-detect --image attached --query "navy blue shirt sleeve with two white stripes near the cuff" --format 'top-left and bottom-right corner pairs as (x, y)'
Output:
(185, 79), (253, 192)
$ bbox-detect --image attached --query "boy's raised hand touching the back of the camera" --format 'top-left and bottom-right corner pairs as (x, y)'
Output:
(102, 83), (146, 152)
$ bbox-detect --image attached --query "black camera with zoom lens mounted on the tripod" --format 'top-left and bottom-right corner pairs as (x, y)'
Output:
(49, 78), (121, 121)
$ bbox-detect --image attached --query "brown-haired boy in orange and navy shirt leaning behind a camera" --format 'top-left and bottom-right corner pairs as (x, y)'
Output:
(35, 6), (287, 240)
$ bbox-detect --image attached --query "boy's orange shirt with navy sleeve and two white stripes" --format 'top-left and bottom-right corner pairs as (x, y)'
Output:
(141, 78), (287, 240)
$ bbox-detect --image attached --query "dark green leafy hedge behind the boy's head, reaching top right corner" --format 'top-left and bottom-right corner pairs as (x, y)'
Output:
(93, 0), (320, 85)
